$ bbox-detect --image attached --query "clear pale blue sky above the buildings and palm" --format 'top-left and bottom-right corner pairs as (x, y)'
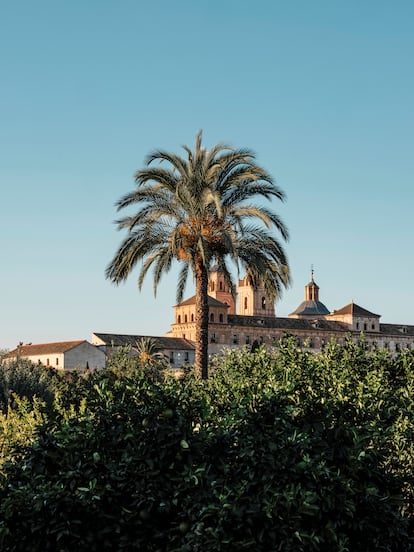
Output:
(0, 0), (414, 349)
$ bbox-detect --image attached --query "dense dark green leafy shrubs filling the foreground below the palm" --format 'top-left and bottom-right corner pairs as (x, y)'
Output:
(0, 340), (414, 552)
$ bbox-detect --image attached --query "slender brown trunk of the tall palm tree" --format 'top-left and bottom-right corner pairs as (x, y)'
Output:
(195, 259), (208, 379)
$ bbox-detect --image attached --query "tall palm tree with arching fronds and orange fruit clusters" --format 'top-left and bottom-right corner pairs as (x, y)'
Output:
(106, 131), (290, 379)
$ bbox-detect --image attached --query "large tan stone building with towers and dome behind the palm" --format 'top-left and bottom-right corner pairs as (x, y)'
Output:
(167, 271), (414, 354)
